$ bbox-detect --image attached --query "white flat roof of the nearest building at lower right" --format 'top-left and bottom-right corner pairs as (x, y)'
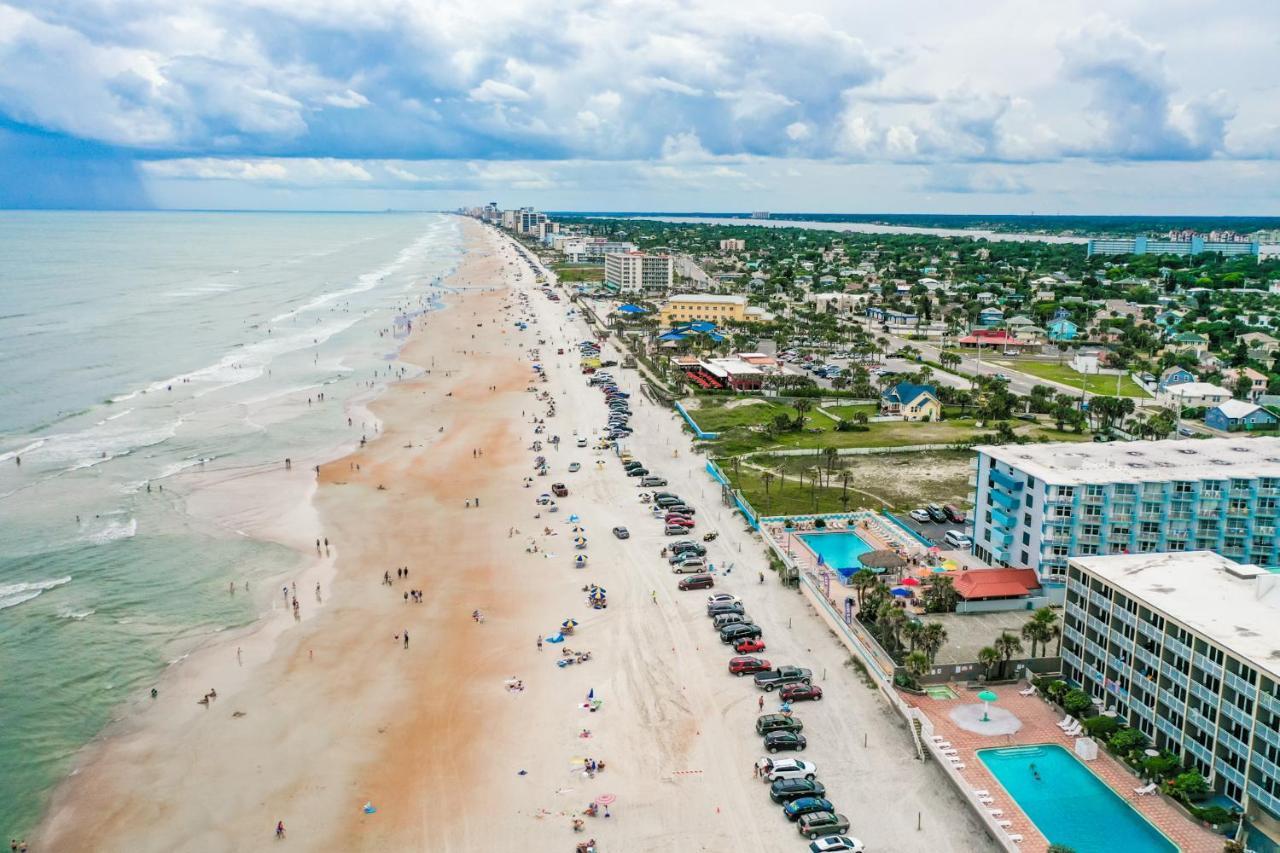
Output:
(1071, 551), (1280, 679)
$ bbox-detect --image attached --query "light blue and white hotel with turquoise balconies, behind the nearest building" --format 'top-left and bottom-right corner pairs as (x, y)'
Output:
(969, 437), (1280, 583)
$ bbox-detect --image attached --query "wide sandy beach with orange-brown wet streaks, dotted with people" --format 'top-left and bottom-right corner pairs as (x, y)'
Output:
(32, 220), (992, 853)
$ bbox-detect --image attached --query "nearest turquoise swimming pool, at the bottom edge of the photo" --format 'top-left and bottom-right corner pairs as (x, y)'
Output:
(978, 744), (1178, 853)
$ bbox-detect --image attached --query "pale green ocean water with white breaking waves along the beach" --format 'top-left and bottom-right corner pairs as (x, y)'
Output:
(0, 211), (462, 838)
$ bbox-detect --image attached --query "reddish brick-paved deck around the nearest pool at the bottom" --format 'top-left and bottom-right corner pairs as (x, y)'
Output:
(900, 684), (1224, 853)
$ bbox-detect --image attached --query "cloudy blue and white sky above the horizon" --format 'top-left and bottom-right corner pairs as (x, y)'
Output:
(0, 0), (1280, 215)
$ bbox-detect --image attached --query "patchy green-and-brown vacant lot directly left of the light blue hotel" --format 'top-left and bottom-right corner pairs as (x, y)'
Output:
(717, 451), (972, 515)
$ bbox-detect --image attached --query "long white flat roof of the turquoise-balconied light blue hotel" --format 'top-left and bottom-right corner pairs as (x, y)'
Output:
(974, 437), (1280, 485)
